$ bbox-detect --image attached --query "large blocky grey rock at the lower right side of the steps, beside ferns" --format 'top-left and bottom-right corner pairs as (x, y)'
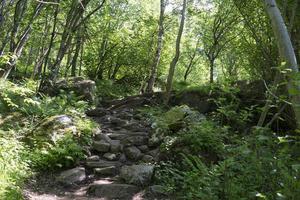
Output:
(120, 165), (154, 186)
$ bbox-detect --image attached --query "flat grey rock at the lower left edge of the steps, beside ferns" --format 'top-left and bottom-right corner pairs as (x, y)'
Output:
(56, 167), (86, 185)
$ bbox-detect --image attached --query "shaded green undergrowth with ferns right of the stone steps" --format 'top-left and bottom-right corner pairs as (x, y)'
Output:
(143, 86), (300, 200)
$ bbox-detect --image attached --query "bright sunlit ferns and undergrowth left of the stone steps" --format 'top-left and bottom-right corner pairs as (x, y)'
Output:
(0, 80), (96, 200)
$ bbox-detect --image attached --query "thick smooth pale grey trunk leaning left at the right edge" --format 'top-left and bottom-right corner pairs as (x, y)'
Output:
(264, 0), (300, 128)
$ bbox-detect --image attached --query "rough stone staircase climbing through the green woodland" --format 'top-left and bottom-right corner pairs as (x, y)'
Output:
(58, 108), (168, 200)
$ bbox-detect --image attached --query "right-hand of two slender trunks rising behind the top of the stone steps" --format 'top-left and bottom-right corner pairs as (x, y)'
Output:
(164, 0), (187, 104)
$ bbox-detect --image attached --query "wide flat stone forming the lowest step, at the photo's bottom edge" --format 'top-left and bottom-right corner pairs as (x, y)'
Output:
(88, 184), (139, 200)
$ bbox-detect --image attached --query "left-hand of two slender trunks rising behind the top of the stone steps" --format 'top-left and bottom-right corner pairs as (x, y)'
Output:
(146, 0), (166, 92)
